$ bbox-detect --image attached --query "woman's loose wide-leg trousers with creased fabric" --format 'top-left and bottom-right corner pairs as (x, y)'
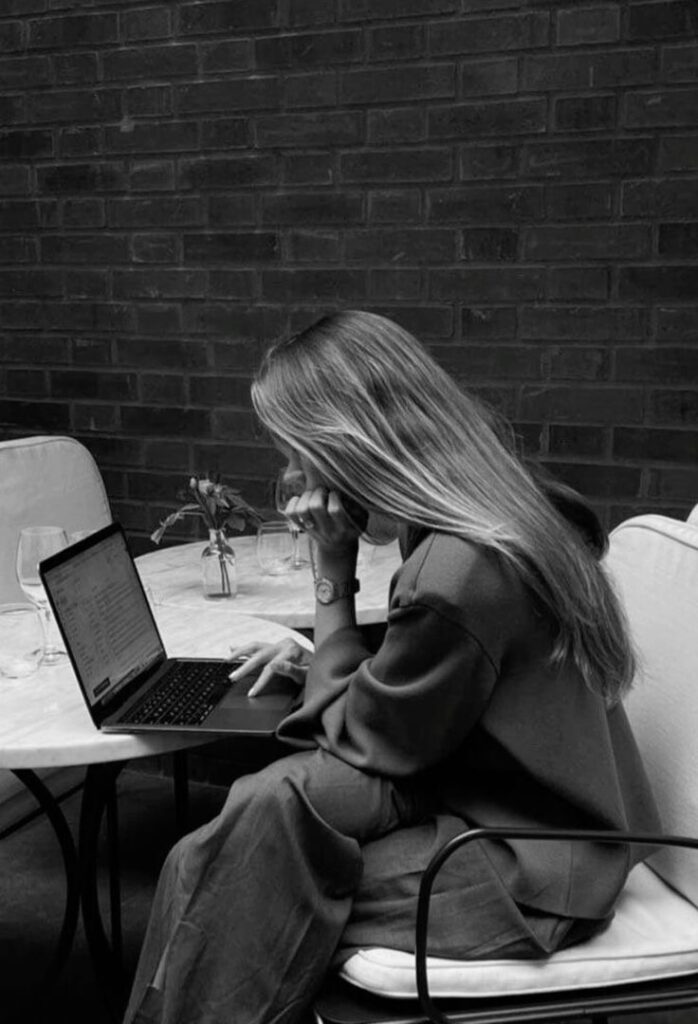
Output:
(125, 750), (577, 1024)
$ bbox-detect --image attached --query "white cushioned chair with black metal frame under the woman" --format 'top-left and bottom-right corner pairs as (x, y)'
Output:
(315, 515), (698, 1024)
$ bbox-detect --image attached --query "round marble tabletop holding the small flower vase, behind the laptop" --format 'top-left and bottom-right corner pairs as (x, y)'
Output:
(136, 536), (401, 630)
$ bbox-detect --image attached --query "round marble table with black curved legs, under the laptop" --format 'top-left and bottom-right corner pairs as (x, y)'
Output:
(0, 600), (311, 1018)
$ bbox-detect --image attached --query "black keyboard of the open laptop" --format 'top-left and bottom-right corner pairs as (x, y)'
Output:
(120, 662), (248, 725)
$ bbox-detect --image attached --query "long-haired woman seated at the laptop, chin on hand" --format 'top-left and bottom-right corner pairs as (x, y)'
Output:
(127, 312), (658, 1024)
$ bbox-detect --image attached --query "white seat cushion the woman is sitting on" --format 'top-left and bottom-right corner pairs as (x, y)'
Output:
(340, 864), (698, 998)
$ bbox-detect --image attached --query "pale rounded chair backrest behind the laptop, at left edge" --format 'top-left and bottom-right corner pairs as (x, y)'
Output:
(0, 436), (112, 601)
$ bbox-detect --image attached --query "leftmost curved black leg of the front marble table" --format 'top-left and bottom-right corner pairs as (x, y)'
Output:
(11, 768), (80, 998)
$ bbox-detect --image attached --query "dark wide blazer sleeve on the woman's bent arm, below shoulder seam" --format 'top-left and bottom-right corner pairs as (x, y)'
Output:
(277, 603), (497, 777)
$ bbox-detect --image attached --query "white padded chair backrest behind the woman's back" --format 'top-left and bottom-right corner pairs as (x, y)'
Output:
(606, 515), (698, 905)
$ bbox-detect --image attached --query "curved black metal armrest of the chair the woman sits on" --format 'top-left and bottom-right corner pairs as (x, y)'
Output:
(415, 827), (698, 1024)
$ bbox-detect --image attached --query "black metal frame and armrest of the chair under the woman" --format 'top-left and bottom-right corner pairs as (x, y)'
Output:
(317, 828), (698, 1024)
